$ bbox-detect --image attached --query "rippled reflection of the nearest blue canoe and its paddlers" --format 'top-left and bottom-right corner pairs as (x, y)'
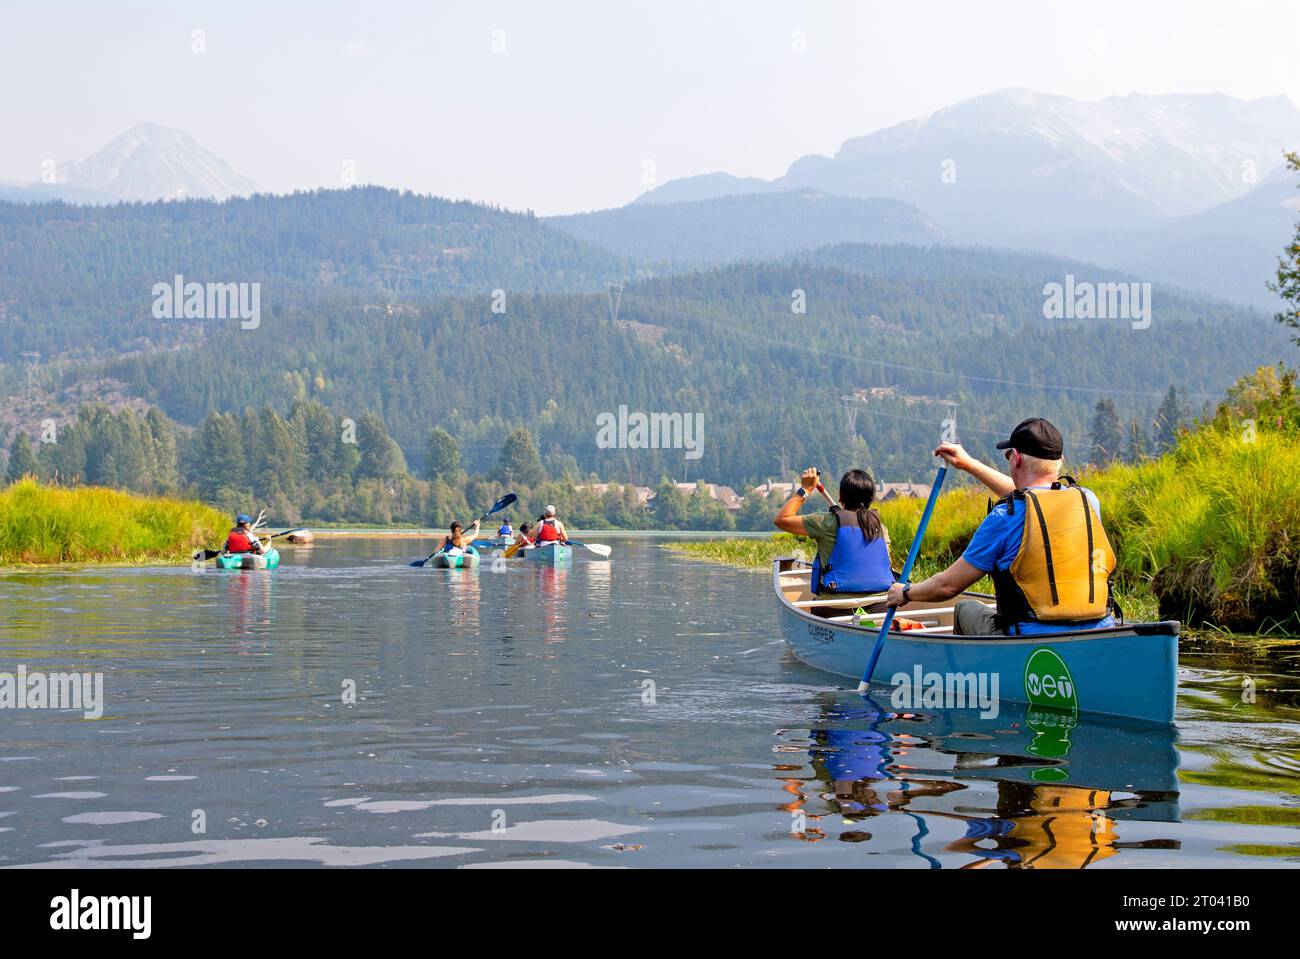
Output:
(783, 693), (1179, 869)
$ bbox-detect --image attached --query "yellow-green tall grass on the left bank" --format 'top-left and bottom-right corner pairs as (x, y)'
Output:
(0, 480), (228, 565)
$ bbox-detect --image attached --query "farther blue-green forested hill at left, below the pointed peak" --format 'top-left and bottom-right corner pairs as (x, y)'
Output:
(0, 187), (628, 363)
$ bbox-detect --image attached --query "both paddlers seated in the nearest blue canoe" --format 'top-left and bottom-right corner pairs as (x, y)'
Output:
(775, 417), (1117, 635)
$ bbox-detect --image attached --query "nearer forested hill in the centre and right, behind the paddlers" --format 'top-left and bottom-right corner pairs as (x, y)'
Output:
(76, 247), (1287, 483)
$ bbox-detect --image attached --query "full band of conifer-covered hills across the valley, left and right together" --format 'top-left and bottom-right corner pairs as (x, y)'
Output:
(0, 190), (1290, 504)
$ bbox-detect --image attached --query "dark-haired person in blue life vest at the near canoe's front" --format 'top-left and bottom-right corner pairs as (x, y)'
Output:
(772, 467), (894, 595)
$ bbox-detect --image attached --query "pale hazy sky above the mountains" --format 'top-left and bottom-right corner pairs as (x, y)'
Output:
(0, 0), (1300, 213)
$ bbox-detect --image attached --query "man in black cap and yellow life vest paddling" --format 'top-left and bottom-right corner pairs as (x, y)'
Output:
(889, 417), (1117, 635)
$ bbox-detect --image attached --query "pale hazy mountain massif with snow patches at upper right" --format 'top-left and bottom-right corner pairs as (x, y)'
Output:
(600, 90), (1300, 309)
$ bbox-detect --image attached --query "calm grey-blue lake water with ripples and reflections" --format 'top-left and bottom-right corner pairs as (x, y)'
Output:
(0, 535), (1300, 869)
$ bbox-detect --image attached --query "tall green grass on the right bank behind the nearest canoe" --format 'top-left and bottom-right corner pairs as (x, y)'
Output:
(670, 366), (1300, 634)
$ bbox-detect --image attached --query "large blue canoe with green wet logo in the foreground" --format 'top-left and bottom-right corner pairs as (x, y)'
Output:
(772, 556), (1179, 724)
